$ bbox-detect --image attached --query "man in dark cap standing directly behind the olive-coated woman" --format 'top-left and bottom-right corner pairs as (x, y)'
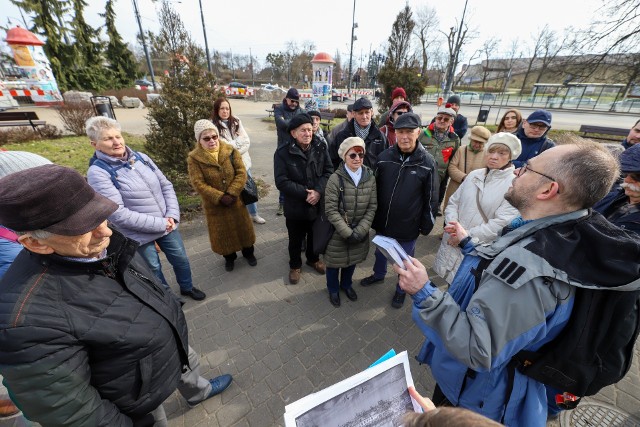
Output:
(329, 98), (389, 169)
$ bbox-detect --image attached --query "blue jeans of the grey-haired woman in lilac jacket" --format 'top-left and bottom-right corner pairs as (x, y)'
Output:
(138, 230), (193, 292)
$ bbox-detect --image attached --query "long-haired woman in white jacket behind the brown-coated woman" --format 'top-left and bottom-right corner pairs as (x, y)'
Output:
(211, 97), (266, 224)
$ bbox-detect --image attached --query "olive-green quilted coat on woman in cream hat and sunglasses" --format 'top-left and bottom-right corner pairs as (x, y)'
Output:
(324, 163), (378, 268)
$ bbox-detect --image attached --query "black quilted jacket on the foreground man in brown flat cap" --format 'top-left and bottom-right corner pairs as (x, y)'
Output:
(0, 231), (188, 426)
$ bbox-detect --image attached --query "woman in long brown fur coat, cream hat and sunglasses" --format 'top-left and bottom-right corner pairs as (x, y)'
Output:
(187, 120), (257, 271)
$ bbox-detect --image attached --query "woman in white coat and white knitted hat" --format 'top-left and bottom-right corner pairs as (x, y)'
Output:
(433, 132), (522, 283)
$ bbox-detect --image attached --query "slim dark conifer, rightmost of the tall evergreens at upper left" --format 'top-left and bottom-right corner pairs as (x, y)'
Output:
(100, 0), (138, 88)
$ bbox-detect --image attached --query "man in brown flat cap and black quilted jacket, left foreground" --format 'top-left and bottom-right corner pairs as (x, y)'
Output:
(0, 165), (231, 426)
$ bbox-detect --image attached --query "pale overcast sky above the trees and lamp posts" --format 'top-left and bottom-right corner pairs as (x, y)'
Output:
(0, 0), (603, 66)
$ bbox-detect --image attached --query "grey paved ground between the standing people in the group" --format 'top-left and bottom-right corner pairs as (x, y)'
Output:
(112, 100), (640, 427)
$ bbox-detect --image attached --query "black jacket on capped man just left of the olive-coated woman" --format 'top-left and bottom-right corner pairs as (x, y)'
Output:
(273, 136), (333, 221)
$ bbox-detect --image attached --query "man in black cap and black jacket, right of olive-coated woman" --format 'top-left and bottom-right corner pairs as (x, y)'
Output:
(360, 113), (438, 308)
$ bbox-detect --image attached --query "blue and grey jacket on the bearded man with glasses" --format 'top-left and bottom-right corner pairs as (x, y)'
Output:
(413, 210), (640, 427)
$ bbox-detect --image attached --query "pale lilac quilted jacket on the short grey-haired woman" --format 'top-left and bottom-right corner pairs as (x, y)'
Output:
(87, 147), (180, 245)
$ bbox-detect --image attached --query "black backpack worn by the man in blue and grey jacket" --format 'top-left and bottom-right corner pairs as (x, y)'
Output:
(473, 258), (640, 409)
